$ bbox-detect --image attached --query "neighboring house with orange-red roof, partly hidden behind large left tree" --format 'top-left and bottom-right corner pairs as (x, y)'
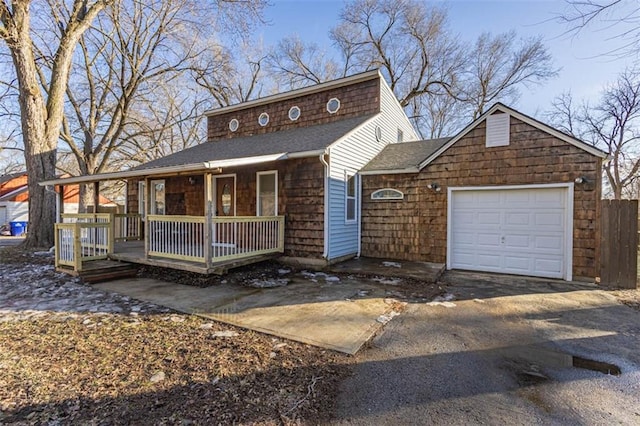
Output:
(0, 172), (117, 230)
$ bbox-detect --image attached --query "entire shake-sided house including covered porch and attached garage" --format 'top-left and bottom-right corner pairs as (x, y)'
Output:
(42, 71), (605, 280)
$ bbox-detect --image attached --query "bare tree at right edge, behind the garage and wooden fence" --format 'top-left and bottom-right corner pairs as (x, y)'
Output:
(548, 70), (640, 199)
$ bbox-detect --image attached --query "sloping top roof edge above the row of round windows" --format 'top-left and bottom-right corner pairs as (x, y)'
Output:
(204, 69), (384, 117)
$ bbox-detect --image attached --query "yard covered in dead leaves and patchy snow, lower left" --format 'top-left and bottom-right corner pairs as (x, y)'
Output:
(0, 248), (351, 425)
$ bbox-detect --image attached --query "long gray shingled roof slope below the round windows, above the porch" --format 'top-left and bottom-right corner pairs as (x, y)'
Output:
(133, 115), (372, 170)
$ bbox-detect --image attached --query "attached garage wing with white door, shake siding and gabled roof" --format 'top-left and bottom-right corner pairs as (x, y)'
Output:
(361, 104), (606, 280)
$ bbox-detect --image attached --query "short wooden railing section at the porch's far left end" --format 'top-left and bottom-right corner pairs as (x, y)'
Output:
(55, 221), (113, 271)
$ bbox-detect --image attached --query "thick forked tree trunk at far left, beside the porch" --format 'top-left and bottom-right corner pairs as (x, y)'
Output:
(0, 0), (110, 247)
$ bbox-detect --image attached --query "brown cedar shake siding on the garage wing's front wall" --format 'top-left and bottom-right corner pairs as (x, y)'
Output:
(362, 116), (602, 278)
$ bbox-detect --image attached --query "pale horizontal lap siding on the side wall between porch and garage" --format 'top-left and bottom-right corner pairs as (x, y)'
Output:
(327, 78), (418, 260)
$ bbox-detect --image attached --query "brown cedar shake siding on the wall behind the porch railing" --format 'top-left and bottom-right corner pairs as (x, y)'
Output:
(127, 157), (324, 258)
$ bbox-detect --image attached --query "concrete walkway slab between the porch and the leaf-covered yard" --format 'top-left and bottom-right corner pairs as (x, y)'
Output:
(95, 272), (416, 354)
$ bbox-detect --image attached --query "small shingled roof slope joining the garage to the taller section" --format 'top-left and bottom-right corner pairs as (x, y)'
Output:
(362, 138), (451, 174)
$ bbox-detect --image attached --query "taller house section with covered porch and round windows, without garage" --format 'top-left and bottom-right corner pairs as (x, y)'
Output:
(42, 70), (418, 273)
